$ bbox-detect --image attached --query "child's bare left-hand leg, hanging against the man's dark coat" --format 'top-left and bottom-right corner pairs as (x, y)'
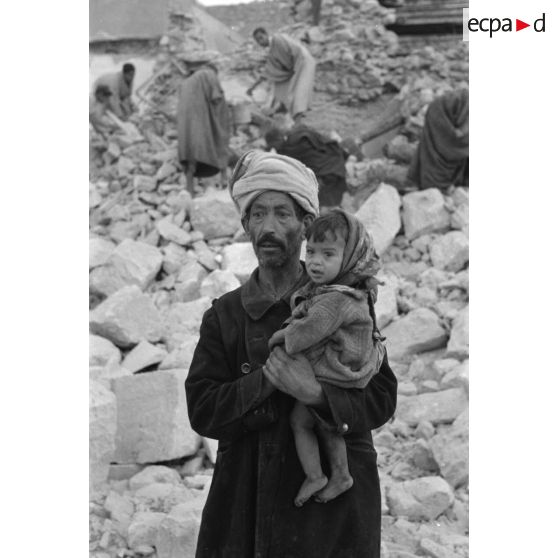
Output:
(290, 402), (327, 507)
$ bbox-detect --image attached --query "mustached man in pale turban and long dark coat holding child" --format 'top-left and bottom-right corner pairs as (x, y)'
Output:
(186, 151), (397, 558)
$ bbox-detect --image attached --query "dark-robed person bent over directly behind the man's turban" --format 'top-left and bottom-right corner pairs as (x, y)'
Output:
(264, 124), (347, 208)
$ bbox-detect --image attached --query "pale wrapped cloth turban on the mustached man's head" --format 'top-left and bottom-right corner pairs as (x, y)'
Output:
(229, 151), (320, 218)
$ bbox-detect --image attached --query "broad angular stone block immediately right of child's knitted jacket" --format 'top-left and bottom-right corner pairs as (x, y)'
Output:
(382, 308), (448, 359)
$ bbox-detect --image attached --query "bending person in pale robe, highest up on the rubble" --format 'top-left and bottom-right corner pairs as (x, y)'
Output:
(247, 27), (316, 122)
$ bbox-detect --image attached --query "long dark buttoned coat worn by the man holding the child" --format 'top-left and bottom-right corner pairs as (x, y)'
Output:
(186, 270), (397, 558)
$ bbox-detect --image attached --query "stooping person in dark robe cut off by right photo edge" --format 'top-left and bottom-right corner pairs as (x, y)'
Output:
(408, 89), (469, 190)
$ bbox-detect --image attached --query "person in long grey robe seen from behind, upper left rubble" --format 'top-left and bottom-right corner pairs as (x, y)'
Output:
(177, 64), (231, 196)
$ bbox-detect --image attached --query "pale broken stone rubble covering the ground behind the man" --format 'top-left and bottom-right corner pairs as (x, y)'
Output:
(89, 0), (469, 558)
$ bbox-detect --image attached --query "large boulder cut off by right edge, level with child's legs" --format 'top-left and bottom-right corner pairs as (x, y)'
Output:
(430, 409), (469, 488)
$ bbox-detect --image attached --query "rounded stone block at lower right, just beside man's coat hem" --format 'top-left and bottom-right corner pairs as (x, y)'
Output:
(386, 477), (455, 521)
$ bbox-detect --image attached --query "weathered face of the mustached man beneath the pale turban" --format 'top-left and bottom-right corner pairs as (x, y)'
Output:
(245, 191), (312, 268)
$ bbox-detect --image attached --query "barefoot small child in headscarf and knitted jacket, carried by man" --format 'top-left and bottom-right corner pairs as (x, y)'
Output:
(270, 209), (385, 506)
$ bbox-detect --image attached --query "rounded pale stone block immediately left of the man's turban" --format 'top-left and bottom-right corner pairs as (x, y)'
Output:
(190, 190), (240, 240)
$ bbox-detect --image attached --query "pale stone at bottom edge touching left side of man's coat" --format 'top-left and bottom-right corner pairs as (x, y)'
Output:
(155, 498), (203, 558)
